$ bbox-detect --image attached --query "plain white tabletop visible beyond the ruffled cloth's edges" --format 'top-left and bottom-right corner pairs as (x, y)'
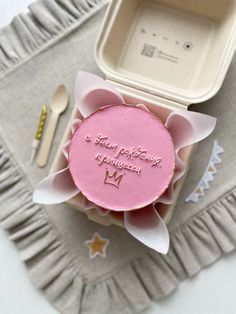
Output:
(0, 0), (236, 314)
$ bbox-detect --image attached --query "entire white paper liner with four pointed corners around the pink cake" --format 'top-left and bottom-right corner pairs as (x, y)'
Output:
(33, 72), (216, 254)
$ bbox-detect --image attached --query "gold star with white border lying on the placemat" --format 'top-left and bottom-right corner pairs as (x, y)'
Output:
(84, 232), (110, 258)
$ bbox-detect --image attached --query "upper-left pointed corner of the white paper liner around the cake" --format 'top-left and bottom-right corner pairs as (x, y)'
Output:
(74, 72), (125, 118)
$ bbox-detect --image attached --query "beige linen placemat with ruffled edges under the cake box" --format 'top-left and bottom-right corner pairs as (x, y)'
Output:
(0, 0), (236, 314)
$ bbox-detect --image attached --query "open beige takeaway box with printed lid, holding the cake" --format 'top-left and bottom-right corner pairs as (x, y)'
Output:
(51, 0), (236, 226)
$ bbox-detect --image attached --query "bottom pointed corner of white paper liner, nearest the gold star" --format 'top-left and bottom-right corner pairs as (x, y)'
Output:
(124, 205), (170, 254)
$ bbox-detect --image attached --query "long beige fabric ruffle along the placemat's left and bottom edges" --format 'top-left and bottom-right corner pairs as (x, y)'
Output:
(0, 140), (236, 314)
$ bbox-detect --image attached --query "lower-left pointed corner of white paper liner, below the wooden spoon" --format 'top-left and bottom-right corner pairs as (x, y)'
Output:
(33, 168), (80, 204)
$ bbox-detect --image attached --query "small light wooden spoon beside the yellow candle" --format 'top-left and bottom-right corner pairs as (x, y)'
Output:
(37, 85), (69, 167)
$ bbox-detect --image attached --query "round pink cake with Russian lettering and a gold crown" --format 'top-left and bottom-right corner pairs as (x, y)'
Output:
(69, 105), (175, 211)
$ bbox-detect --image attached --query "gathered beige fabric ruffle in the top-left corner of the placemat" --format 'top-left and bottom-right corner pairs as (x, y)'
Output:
(0, 0), (107, 75)
